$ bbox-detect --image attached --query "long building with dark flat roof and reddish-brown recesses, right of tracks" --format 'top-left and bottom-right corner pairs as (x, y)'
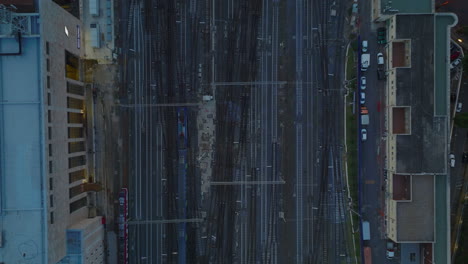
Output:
(372, 0), (457, 263)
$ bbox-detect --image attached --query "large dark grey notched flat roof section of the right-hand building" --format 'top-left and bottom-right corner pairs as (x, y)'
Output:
(395, 14), (448, 174)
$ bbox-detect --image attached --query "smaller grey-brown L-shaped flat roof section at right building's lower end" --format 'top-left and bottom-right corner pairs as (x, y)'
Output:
(397, 175), (435, 242)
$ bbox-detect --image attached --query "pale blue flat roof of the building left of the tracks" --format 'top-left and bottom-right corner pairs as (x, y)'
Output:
(0, 34), (47, 263)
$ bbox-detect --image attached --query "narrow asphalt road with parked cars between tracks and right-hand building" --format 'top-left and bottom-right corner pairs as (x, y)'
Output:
(358, 1), (394, 263)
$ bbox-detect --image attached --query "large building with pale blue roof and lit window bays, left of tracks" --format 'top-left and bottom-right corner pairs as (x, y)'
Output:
(0, 0), (110, 263)
